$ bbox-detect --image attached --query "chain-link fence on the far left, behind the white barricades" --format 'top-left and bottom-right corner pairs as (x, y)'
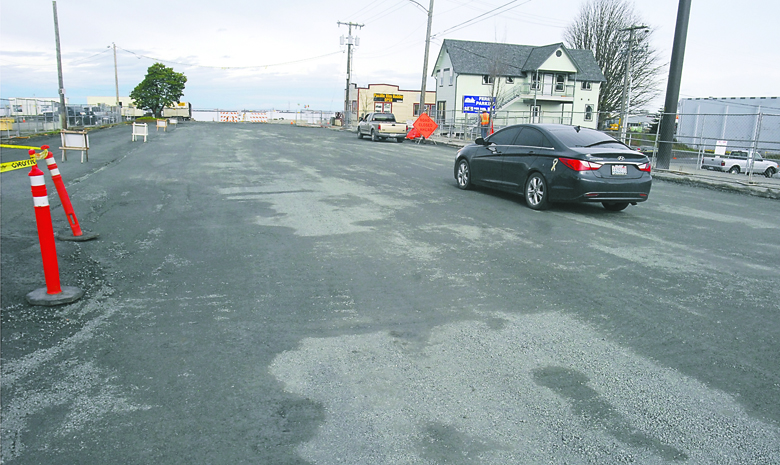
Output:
(0, 98), (122, 139)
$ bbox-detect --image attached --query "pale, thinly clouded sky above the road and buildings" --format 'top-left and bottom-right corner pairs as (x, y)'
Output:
(0, 0), (780, 111)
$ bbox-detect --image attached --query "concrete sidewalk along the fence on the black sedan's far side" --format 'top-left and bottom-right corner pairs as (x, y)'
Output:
(429, 136), (780, 199)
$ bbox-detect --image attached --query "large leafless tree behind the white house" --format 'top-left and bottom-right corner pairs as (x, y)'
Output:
(564, 0), (662, 127)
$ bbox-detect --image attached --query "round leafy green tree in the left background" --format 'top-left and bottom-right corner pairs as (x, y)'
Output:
(130, 63), (187, 118)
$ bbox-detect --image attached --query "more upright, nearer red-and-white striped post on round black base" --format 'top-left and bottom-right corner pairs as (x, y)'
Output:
(26, 165), (84, 306)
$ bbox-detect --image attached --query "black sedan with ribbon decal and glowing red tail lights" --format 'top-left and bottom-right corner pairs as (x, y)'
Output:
(454, 124), (652, 211)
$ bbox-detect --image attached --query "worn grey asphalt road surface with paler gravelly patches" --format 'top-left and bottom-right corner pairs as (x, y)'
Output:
(0, 123), (780, 465)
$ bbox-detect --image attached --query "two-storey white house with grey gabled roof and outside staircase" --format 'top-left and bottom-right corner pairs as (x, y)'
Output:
(432, 39), (606, 128)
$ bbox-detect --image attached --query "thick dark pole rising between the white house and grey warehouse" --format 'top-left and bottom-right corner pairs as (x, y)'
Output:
(656, 0), (691, 169)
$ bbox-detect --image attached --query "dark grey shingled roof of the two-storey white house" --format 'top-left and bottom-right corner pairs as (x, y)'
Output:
(439, 39), (606, 82)
